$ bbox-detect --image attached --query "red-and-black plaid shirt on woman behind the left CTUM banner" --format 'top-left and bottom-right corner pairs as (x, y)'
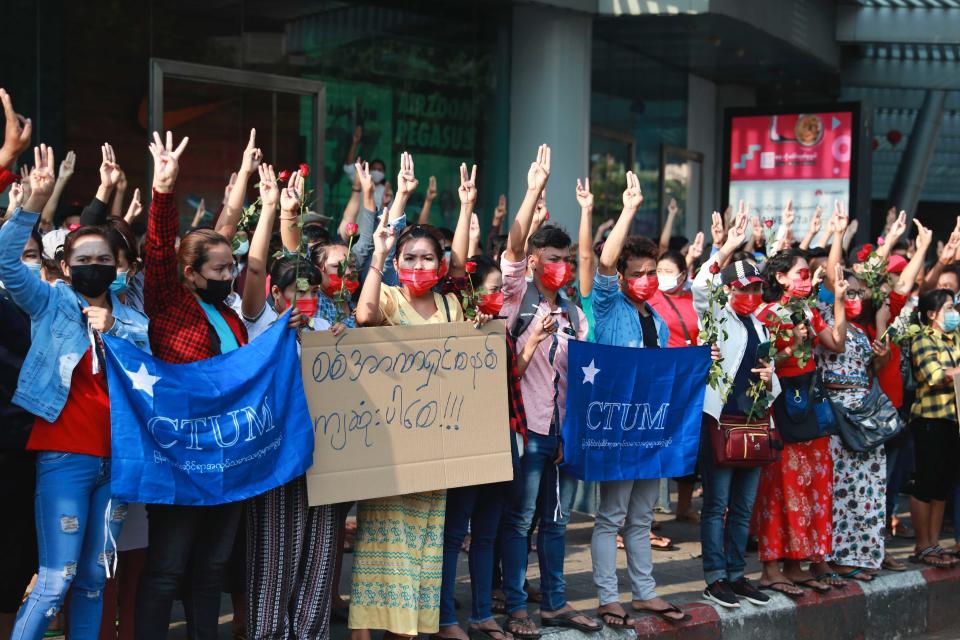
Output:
(143, 191), (247, 364)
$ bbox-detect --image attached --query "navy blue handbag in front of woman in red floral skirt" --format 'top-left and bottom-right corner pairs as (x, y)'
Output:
(773, 372), (837, 442)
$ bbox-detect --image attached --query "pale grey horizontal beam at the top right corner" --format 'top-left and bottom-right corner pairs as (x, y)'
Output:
(836, 4), (960, 44)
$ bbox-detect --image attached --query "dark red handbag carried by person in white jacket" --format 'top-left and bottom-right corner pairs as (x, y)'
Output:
(709, 415), (783, 468)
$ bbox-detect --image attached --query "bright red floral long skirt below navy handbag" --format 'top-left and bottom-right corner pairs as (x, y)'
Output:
(750, 438), (833, 562)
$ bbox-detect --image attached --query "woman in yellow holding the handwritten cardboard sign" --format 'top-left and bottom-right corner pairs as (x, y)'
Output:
(348, 153), (464, 640)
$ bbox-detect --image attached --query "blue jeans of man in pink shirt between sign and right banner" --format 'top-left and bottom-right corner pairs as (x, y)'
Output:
(503, 432), (577, 614)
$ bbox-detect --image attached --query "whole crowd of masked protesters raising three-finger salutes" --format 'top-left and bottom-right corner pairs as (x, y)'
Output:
(0, 82), (960, 640)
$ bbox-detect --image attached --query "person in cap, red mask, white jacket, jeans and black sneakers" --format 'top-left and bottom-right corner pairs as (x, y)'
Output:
(693, 213), (780, 608)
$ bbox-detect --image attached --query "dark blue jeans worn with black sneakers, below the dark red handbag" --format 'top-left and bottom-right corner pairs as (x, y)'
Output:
(700, 416), (760, 585)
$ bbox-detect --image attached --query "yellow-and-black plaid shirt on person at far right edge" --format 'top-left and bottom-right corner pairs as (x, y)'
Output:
(910, 332), (960, 421)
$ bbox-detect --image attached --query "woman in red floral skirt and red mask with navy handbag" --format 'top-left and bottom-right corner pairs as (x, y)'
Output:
(751, 232), (847, 598)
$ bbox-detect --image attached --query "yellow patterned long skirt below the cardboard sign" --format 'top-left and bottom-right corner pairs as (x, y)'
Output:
(348, 491), (447, 636)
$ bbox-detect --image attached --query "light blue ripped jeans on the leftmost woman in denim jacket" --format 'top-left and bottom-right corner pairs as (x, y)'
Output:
(10, 451), (127, 640)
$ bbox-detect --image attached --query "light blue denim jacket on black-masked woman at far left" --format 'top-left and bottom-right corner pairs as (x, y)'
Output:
(0, 208), (150, 422)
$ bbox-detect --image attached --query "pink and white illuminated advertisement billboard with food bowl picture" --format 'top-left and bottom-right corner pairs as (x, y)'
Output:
(724, 104), (859, 245)
